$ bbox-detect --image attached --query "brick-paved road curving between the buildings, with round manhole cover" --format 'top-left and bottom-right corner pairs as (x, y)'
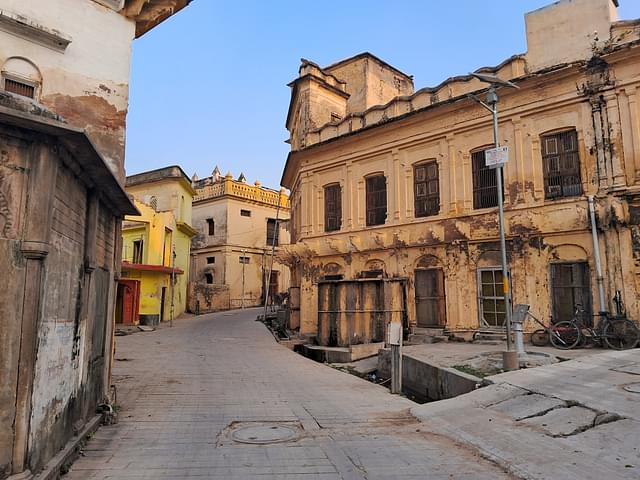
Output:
(64, 310), (512, 480)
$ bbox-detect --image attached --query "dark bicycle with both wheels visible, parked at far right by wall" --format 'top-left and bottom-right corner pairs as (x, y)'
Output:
(548, 306), (640, 350)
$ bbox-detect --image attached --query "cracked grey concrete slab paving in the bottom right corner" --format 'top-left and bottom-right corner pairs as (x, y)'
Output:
(412, 349), (640, 480)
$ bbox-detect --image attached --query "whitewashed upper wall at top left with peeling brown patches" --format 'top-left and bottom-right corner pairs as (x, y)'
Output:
(0, 0), (135, 181)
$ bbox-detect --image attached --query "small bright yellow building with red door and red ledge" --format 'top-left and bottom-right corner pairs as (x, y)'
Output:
(116, 166), (196, 325)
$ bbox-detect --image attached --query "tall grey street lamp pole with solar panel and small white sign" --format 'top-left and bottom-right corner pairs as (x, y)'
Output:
(469, 73), (524, 370)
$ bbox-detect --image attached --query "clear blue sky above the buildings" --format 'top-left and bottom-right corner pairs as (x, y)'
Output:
(126, 0), (640, 187)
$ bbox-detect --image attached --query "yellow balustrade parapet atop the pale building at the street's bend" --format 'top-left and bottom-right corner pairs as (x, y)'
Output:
(193, 175), (289, 209)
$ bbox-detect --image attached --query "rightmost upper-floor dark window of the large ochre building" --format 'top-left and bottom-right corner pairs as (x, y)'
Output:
(542, 130), (582, 199)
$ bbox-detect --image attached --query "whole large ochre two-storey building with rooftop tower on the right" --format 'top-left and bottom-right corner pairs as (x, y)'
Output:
(282, 0), (640, 345)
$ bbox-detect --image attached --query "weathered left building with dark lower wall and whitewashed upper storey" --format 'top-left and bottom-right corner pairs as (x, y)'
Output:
(0, 0), (188, 479)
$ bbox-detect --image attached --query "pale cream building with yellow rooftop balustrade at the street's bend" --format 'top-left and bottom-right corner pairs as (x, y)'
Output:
(189, 167), (289, 312)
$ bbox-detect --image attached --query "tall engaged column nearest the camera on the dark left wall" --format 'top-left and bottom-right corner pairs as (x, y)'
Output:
(12, 143), (58, 473)
